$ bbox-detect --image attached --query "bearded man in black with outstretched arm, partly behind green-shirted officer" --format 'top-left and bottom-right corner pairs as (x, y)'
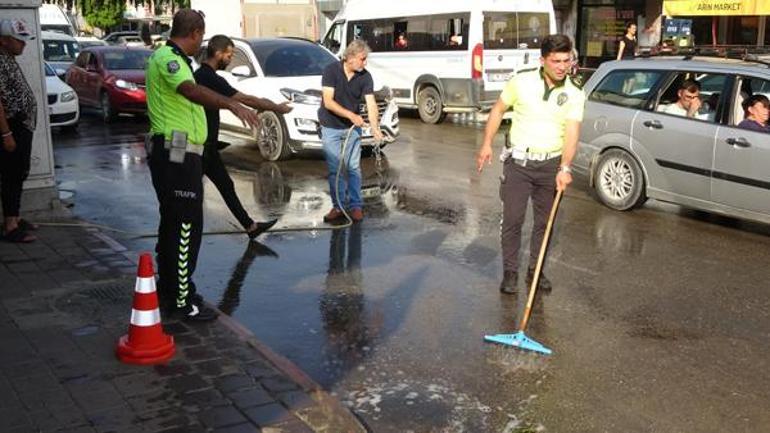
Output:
(194, 35), (292, 239)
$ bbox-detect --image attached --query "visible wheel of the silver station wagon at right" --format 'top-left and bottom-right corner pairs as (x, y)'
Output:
(594, 149), (647, 210)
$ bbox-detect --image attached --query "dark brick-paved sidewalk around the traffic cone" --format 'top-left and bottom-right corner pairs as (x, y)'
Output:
(0, 214), (366, 433)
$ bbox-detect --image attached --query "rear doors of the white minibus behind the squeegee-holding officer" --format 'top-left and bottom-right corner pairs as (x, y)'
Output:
(483, 11), (550, 93)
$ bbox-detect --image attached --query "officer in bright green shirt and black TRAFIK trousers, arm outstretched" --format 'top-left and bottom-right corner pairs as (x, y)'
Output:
(146, 9), (258, 321)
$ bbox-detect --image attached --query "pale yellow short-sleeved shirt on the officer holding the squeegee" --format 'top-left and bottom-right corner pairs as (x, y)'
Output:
(500, 68), (585, 153)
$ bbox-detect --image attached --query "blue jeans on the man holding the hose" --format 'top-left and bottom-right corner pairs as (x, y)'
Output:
(321, 126), (364, 209)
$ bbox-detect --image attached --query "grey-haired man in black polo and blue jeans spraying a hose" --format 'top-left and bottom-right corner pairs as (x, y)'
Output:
(318, 39), (382, 222)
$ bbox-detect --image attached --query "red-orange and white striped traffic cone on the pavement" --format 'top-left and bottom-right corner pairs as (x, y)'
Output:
(116, 253), (176, 365)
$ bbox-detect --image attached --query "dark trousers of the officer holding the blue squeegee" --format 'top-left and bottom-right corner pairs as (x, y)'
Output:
(500, 157), (561, 272)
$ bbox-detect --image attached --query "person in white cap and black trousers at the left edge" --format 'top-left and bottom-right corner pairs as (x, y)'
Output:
(0, 19), (37, 243)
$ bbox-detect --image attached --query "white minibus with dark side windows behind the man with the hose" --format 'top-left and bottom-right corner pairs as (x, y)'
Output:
(322, 0), (556, 123)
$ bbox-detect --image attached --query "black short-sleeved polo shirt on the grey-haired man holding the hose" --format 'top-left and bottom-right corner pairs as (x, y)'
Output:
(318, 62), (374, 129)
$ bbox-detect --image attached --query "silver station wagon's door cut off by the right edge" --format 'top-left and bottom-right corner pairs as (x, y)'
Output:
(711, 78), (770, 215)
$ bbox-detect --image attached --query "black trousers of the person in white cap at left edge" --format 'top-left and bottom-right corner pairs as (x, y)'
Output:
(0, 119), (33, 218)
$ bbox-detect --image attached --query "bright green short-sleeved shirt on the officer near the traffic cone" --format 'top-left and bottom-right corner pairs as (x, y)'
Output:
(147, 41), (208, 145)
